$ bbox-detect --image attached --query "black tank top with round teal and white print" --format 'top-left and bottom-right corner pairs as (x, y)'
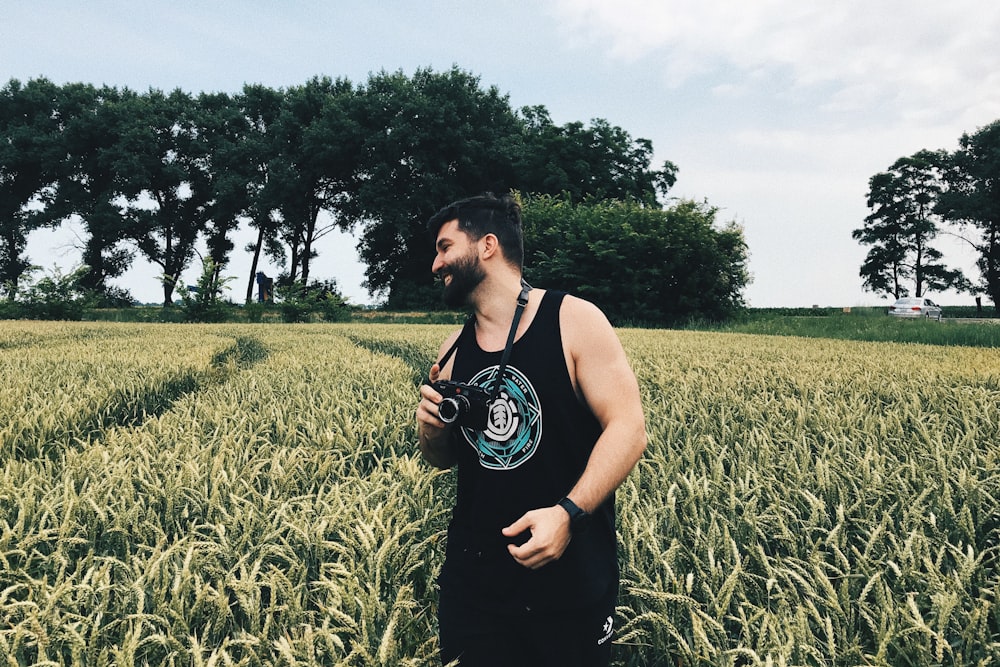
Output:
(441, 291), (618, 609)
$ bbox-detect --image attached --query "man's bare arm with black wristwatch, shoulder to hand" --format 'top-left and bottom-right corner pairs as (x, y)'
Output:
(503, 297), (646, 569)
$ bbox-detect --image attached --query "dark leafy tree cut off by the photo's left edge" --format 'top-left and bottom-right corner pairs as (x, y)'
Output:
(0, 78), (60, 299)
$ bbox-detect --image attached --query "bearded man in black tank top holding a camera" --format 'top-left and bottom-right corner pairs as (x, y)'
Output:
(416, 190), (646, 666)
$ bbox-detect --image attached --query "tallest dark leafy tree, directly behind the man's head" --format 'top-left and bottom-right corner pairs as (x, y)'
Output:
(343, 67), (521, 307)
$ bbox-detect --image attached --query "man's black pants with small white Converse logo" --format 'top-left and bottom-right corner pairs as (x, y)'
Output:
(438, 587), (618, 667)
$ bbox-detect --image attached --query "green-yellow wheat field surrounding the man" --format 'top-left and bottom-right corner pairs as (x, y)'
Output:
(0, 322), (1000, 666)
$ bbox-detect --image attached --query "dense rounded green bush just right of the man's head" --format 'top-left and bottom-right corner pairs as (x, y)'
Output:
(523, 195), (750, 324)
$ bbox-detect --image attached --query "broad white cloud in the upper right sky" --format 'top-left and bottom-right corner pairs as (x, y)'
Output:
(552, 0), (1000, 122)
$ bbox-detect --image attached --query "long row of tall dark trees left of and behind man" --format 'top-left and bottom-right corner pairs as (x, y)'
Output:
(0, 67), (700, 308)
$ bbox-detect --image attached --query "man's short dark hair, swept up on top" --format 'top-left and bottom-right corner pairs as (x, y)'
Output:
(427, 193), (524, 269)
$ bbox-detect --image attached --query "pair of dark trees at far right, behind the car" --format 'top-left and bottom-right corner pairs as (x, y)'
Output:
(852, 120), (1000, 314)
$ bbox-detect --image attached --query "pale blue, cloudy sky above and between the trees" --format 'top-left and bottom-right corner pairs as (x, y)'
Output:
(0, 0), (1000, 307)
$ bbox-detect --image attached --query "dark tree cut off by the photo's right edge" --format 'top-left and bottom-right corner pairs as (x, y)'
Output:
(936, 120), (1000, 314)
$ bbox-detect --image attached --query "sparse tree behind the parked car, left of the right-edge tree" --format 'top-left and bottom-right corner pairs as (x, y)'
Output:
(851, 150), (967, 298)
